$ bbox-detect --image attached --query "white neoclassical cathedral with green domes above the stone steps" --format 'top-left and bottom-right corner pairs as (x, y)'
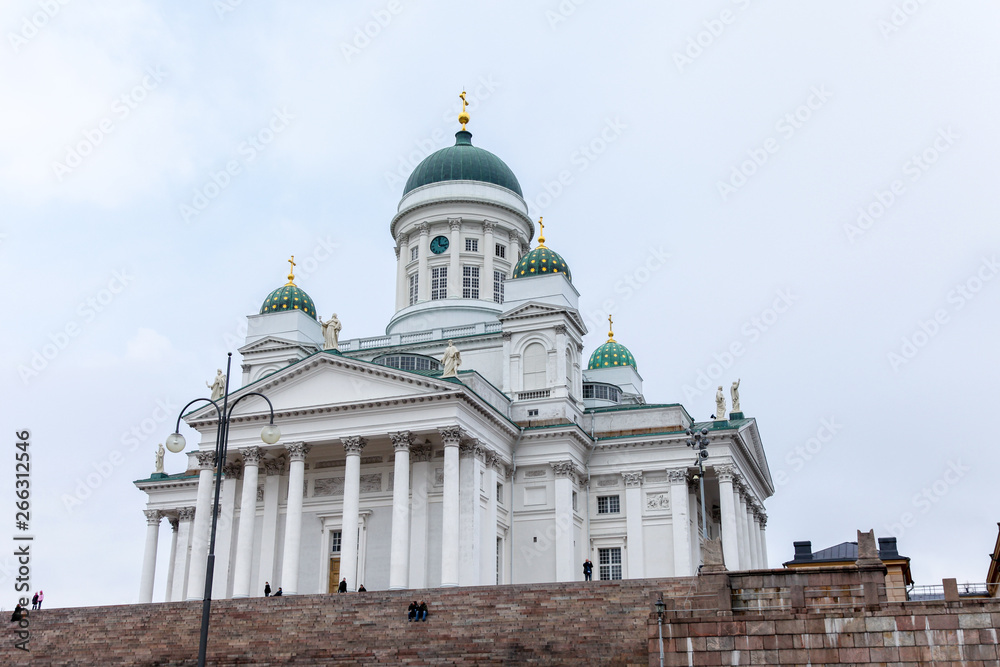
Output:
(135, 102), (774, 602)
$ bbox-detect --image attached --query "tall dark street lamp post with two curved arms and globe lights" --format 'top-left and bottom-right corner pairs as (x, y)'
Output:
(166, 352), (281, 667)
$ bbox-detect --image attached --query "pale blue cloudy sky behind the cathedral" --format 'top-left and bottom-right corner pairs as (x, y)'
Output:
(0, 0), (1000, 608)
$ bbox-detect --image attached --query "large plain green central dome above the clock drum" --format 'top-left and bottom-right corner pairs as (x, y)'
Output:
(403, 130), (523, 196)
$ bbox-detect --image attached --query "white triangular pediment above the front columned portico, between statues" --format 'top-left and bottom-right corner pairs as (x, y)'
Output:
(190, 352), (461, 420)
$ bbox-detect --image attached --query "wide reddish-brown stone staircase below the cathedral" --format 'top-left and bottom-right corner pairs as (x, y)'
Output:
(0, 578), (697, 667)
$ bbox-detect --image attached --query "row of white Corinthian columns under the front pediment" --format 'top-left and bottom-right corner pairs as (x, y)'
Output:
(140, 426), (507, 602)
